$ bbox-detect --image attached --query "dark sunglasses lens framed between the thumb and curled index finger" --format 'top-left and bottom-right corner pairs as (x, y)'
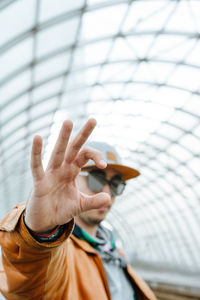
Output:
(88, 170), (106, 192)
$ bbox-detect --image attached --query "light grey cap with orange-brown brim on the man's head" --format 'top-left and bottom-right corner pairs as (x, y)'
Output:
(82, 141), (140, 180)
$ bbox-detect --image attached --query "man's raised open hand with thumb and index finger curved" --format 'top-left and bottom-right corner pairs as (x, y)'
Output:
(26, 120), (109, 231)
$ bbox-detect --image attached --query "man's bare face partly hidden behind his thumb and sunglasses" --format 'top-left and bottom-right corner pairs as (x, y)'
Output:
(77, 168), (120, 225)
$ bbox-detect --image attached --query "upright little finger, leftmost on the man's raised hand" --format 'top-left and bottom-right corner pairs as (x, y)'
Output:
(31, 136), (44, 181)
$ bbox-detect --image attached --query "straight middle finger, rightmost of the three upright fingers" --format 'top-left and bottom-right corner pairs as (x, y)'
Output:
(65, 118), (97, 163)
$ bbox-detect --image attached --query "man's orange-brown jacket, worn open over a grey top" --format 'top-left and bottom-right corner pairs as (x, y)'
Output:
(0, 203), (156, 300)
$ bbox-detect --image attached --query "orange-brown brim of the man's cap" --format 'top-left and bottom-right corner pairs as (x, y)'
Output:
(83, 163), (140, 181)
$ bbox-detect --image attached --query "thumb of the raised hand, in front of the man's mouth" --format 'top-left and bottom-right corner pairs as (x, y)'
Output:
(82, 193), (111, 211)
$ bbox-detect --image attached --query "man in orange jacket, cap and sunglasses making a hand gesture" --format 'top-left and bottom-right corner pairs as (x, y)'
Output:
(0, 119), (156, 300)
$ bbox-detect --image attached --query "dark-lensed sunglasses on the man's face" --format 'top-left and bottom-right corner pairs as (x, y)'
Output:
(80, 169), (126, 196)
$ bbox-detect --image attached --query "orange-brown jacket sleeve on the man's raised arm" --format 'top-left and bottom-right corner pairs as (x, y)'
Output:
(0, 203), (74, 300)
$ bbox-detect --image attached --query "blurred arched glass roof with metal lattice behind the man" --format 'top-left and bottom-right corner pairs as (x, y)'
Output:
(0, 0), (200, 300)
